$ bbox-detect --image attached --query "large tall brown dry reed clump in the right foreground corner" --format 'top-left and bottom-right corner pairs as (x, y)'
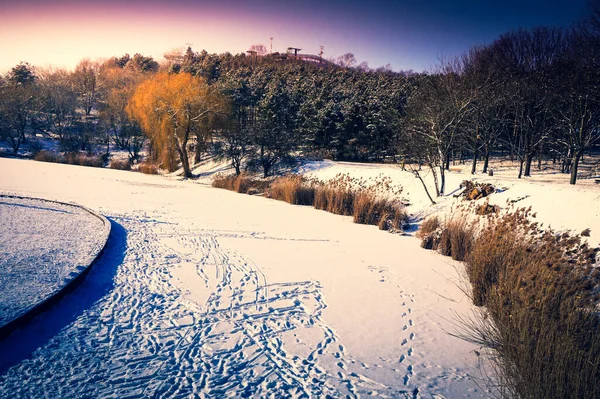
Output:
(454, 210), (600, 398)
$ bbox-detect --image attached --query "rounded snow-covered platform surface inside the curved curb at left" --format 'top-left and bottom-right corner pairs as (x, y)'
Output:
(0, 196), (109, 327)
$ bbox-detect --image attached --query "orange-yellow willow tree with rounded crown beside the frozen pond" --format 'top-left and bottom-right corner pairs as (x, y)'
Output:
(127, 73), (227, 177)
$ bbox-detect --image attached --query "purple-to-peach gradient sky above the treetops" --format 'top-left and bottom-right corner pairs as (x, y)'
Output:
(0, 0), (587, 73)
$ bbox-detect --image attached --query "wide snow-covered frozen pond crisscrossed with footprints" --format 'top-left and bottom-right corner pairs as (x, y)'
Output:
(0, 159), (485, 398)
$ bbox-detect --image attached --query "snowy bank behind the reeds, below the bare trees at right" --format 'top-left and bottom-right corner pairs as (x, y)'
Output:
(299, 161), (600, 245)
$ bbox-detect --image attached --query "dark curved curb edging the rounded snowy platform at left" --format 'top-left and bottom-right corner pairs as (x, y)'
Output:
(0, 194), (111, 339)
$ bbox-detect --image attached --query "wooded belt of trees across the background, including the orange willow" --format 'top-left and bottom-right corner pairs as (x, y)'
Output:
(0, 0), (600, 189)
